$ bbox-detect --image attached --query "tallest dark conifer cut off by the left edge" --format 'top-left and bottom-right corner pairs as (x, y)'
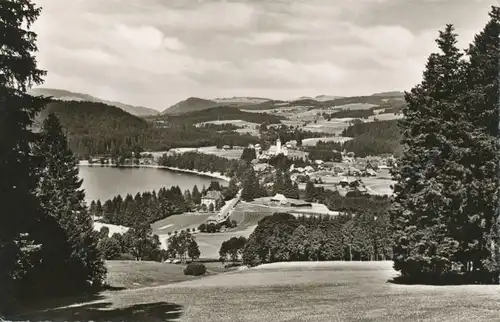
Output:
(0, 0), (47, 314)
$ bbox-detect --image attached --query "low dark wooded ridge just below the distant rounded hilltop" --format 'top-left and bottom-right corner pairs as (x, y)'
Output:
(162, 106), (283, 124)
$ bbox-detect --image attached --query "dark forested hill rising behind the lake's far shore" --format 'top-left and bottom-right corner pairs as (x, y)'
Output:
(37, 100), (258, 159)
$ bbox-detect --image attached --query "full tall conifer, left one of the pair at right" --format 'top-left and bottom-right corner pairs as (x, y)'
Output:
(391, 25), (467, 279)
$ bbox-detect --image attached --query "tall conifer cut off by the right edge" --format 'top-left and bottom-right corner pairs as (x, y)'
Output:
(462, 7), (500, 283)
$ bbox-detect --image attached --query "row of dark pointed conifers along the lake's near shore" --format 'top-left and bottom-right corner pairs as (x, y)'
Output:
(89, 181), (231, 227)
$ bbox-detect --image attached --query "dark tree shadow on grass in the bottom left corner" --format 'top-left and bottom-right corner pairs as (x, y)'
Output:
(7, 302), (182, 322)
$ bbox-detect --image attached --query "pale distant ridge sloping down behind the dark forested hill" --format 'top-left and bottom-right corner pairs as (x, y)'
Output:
(31, 88), (158, 116)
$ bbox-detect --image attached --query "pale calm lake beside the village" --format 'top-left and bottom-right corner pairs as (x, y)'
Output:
(79, 166), (227, 203)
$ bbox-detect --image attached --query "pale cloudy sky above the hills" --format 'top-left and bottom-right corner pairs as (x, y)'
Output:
(34, 0), (500, 110)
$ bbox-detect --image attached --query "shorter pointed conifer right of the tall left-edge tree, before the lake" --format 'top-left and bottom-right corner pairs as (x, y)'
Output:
(34, 114), (106, 289)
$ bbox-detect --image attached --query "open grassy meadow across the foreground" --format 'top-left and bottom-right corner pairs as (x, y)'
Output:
(14, 262), (500, 322)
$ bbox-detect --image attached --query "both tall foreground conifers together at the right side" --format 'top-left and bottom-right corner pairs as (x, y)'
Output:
(391, 8), (500, 283)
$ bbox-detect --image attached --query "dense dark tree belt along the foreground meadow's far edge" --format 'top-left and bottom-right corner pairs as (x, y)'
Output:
(243, 212), (392, 266)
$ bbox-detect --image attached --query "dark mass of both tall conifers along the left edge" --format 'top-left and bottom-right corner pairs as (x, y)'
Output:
(0, 0), (105, 316)
